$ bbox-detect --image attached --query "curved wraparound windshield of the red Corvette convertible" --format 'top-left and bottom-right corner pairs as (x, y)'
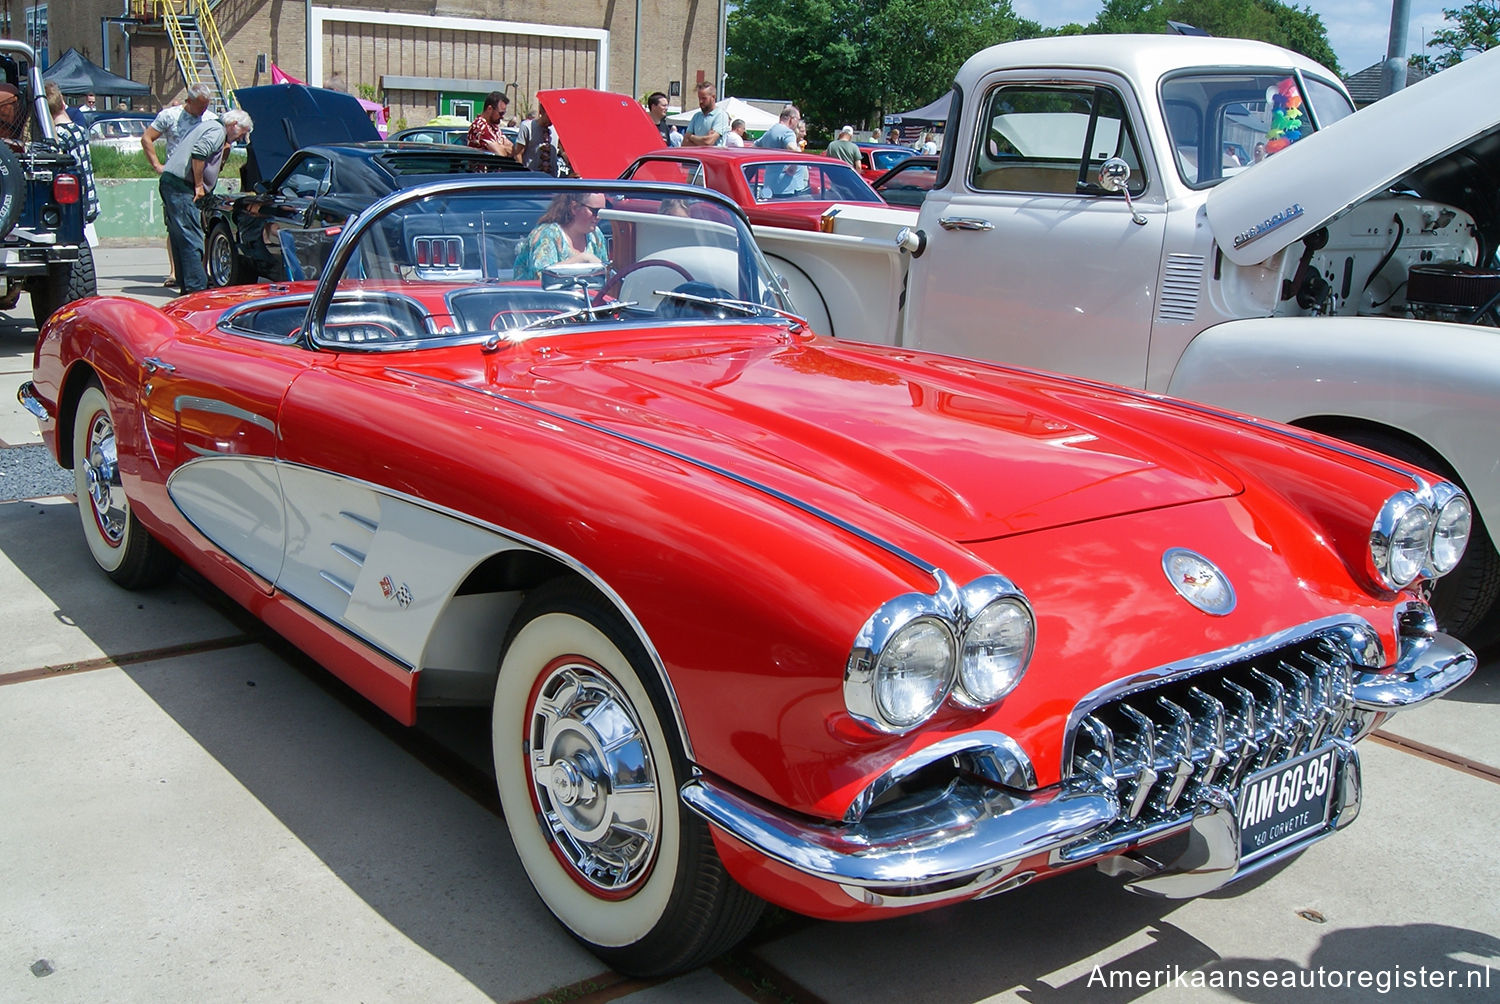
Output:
(279, 182), (792, 351)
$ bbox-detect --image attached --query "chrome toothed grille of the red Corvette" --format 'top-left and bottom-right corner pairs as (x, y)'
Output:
(1068, 633), (1358, 849)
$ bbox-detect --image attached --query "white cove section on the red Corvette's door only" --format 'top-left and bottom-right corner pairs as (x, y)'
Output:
(167, 456), (285, 582)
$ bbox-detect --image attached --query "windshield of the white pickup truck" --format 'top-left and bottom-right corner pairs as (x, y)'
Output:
(1161, 71), (1355, 188)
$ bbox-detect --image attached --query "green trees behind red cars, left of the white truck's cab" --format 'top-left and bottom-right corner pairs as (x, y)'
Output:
(725, 0), (1040, 131)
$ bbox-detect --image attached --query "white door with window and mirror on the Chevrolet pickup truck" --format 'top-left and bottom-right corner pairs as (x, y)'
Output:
(908, 71), (1167, 386)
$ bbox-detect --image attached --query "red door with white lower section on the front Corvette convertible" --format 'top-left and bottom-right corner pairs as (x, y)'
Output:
(141, 321), (320, 591)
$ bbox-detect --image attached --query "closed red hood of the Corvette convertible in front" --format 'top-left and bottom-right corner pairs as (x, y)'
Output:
(497, 332), (1241, 542)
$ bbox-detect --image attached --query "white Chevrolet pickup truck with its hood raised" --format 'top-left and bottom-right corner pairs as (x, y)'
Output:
(756, 36), (1500, 641)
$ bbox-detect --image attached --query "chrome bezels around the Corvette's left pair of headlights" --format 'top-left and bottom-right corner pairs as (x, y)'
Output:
(843, 572), (1037, 735)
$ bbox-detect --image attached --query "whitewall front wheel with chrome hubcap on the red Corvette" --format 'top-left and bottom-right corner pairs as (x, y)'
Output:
(492, 581), (762, 975)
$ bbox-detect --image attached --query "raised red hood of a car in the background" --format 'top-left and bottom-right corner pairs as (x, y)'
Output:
(537, 87), (662, 179)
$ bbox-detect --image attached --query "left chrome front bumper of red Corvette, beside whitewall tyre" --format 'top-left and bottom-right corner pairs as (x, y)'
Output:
(681, 777), (1119, 906)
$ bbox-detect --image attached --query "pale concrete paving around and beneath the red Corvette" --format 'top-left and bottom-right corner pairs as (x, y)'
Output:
(0, 248), (1500, 1004)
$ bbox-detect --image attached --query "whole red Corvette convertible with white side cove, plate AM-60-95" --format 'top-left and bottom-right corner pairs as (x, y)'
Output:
(21, 179), (1475, 974)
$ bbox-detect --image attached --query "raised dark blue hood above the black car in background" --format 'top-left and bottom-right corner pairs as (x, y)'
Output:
(234, 84), (381, 188)
